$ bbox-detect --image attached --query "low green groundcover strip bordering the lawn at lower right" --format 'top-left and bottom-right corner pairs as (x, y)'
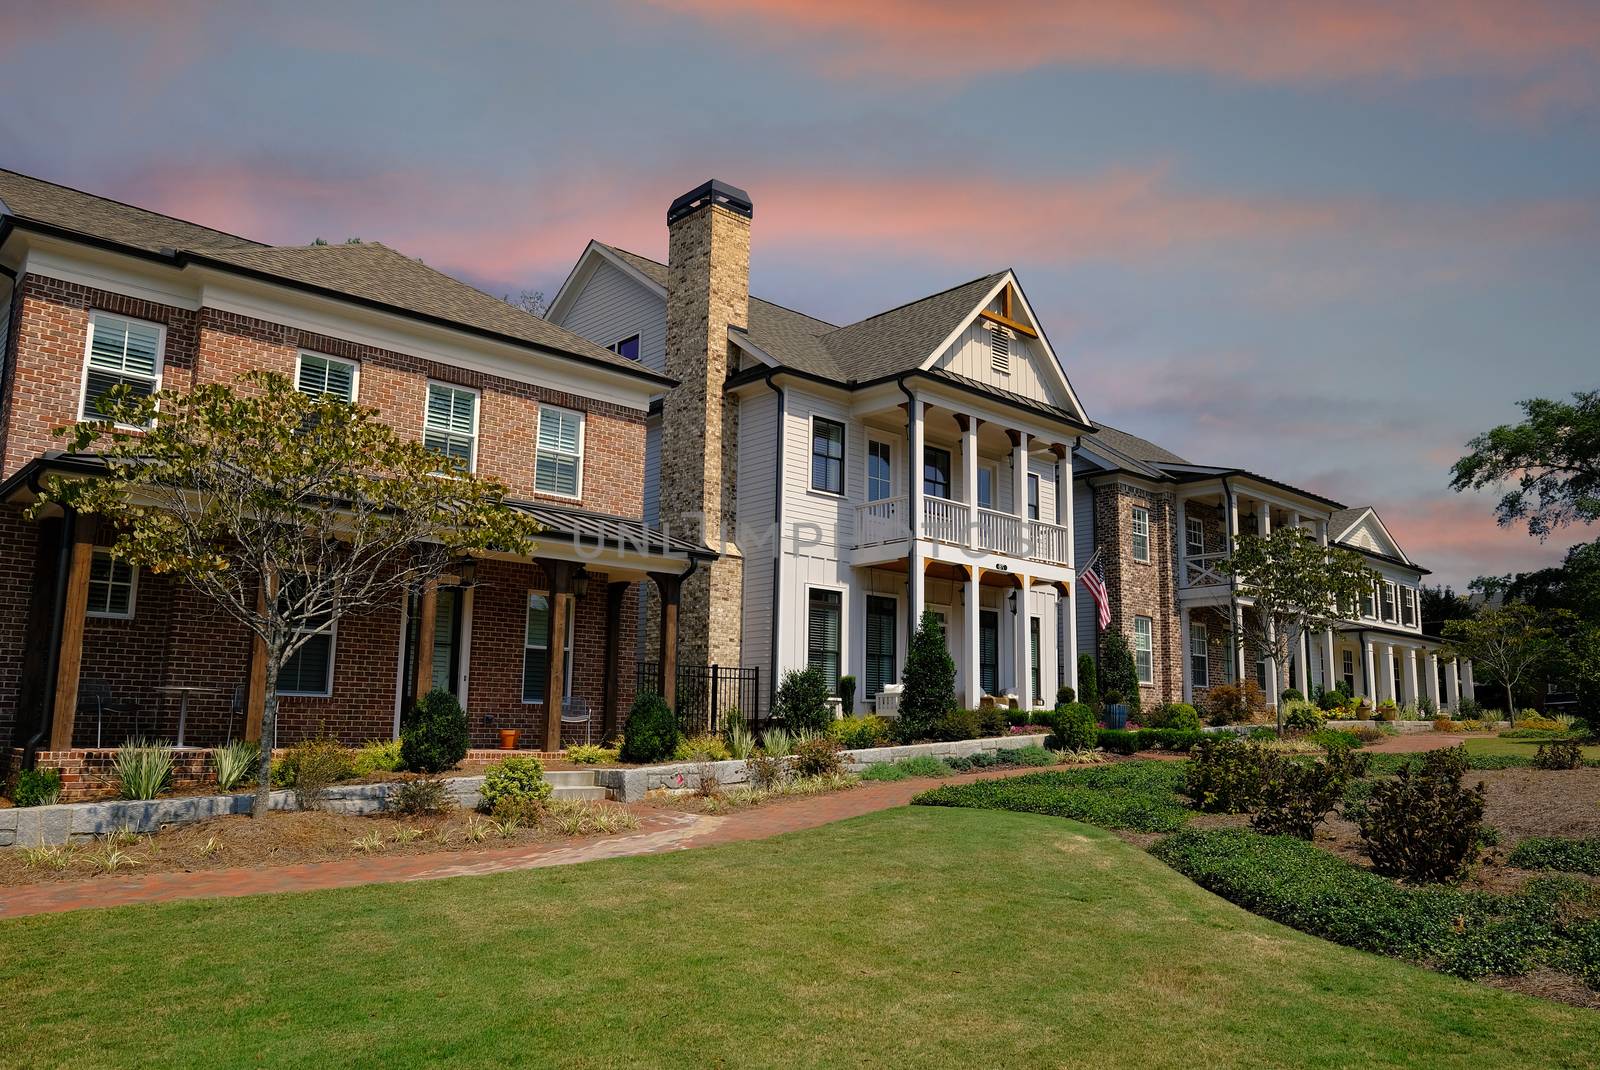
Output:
(1152, 828), (1600, 984)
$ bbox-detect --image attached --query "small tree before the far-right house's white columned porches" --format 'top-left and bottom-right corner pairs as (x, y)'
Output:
(1218, 528), (1378, 733)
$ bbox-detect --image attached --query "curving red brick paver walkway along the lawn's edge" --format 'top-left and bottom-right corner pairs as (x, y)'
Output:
(0, 769), (1026, 918)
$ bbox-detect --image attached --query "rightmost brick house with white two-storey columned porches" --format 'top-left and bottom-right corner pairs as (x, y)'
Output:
(1074, 424), (1474, 709)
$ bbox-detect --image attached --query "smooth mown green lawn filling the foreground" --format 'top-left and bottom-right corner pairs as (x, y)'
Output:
(0, 808), (1600, 1070)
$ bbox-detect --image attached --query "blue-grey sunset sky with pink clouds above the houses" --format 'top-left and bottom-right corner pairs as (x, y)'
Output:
(0, 0), (1600, 587)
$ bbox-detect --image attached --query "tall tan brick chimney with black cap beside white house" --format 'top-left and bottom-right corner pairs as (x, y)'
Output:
(661, 181), (754, 667)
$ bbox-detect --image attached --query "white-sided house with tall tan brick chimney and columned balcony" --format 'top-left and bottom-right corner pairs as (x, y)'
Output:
(547, 181), (1093, 709)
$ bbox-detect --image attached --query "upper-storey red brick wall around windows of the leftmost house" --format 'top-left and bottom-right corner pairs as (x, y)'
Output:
(0, 275), (645, 517)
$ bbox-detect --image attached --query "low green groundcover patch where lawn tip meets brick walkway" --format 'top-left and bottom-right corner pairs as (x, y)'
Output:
(912, 761), (1189, 832)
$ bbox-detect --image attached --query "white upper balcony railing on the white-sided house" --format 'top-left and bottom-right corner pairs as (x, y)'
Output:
(856, 496), (1072, 566)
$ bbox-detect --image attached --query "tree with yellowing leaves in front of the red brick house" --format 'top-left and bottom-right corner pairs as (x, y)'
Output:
(35, 371), (538, 816)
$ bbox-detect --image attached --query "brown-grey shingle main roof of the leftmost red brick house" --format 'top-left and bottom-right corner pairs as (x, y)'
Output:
(0, 171), (666, 382)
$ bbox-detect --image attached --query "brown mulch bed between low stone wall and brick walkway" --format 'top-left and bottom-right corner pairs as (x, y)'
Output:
(0, 803), (643, 888)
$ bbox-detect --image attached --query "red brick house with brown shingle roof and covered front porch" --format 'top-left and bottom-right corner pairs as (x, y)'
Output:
(0, 171), (717, 761)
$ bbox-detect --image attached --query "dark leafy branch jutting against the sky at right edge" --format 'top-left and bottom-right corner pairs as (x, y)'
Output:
(1450, 390), (1600, 539)
